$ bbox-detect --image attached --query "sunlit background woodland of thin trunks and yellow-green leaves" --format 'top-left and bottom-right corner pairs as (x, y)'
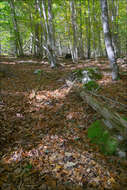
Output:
(0, 0), (127, 60)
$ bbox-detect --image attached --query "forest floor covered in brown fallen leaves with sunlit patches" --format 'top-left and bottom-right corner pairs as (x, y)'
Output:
(0, 57), (127, 190)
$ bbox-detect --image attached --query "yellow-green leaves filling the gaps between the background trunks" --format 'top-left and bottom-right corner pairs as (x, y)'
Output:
(0, 0), (127, 54)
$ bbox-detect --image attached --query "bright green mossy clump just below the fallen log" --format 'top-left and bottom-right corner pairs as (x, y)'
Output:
(88, 120), (118, 155)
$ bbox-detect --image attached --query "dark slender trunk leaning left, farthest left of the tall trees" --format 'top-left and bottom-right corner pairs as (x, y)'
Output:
(10, 0), (23, 56)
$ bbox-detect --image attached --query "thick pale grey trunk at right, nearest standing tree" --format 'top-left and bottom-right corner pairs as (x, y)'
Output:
(100, 0), (119, 80)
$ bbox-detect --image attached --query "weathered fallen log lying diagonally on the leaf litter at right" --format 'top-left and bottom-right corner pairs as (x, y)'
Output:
(80, 91), (127, 157)
